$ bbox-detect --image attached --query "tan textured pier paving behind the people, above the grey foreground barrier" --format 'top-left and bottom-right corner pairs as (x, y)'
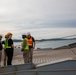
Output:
(1, 48), (76, 66)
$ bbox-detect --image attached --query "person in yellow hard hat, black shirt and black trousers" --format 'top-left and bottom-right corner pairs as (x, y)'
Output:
(5, 32), (14, 65)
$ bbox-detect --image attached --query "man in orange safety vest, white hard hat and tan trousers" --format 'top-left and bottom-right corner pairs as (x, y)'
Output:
(27, 32), (35, 62)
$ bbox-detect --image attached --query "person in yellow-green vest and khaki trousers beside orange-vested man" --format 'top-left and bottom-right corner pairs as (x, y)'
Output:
(21, 34), (29, 63)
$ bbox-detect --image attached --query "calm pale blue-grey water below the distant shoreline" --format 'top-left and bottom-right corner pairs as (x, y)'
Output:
(14, 39), (76, 48)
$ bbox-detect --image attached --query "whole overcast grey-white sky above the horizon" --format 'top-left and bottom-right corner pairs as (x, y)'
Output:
(0, 0), (76, 38)
